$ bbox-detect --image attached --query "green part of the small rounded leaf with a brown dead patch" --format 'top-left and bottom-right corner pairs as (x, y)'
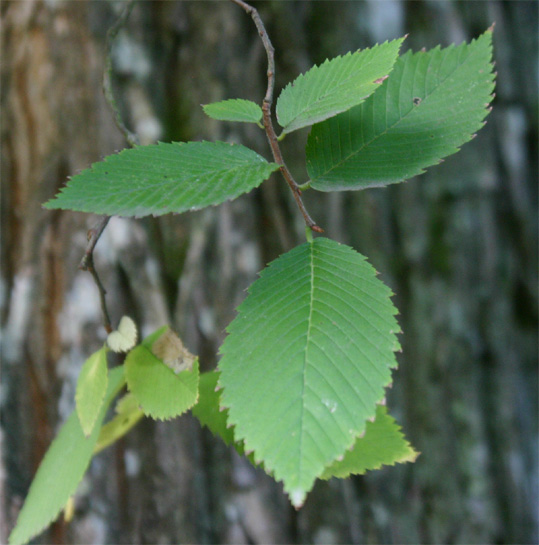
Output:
(125, 326), (199, 420)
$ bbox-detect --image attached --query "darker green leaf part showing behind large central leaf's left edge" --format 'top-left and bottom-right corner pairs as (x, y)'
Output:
(192, 371), (234, 445)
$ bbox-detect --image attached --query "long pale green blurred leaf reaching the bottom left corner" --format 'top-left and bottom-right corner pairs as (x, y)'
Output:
(9, 367), (125, 545)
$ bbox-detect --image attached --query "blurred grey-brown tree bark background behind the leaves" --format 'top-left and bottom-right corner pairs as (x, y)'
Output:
(0, 0), (539, 544)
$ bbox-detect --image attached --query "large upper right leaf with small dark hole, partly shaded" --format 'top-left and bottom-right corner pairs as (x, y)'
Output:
(307, 31), (494, 191)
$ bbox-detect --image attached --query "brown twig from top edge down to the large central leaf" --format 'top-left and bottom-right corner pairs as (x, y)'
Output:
(231, 0), (324, 233)
